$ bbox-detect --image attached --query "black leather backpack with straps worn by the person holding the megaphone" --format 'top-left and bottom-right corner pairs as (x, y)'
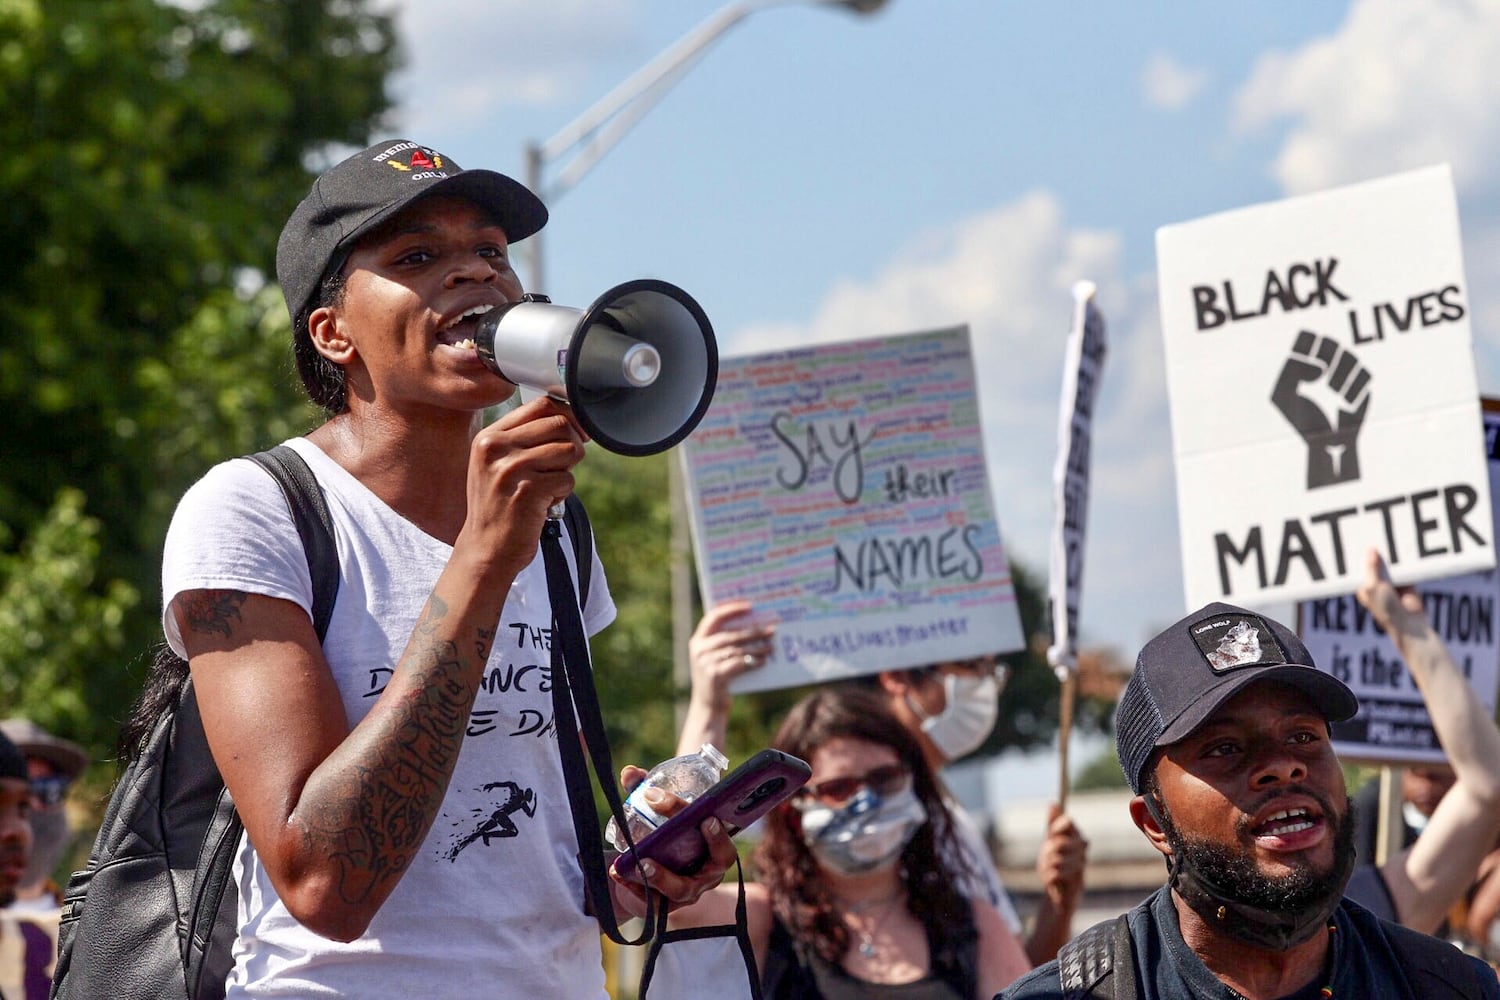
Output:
(50, 445), (593, 1000)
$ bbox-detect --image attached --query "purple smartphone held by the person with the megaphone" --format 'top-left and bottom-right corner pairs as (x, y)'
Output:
(614, 750), (813, 879)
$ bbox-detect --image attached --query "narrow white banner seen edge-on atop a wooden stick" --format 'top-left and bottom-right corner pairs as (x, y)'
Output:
(1047, 282), (1106, 679)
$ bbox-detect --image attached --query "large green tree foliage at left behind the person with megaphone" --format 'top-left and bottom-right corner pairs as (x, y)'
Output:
(0, 0), (396, 756)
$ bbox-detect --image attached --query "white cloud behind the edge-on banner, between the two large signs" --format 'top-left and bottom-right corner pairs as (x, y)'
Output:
(723, 192), (1182, 648)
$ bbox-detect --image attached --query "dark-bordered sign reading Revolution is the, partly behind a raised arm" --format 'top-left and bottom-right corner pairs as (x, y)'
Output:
(1298, 400), (1500, 763)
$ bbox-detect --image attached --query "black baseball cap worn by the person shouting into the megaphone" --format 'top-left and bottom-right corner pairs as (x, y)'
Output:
(276, 139), (548, 324)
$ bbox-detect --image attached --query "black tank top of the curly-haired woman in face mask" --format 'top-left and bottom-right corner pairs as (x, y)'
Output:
(761, 910), (980, 1000)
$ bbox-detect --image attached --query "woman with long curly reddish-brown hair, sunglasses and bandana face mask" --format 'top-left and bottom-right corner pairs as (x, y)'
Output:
(672, 687), (1031, 1000)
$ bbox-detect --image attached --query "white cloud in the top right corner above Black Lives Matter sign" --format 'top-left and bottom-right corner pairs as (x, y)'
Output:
(1236, 0), (1500, 193)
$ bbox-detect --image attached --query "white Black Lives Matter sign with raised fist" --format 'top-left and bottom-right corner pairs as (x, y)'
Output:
(1157, 166), (1496, 607)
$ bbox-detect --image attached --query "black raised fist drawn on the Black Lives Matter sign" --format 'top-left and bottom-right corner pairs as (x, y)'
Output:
(1271, 330), (1370, 490)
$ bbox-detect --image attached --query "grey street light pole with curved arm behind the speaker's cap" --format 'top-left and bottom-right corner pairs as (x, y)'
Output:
(524, 0), (887, 292)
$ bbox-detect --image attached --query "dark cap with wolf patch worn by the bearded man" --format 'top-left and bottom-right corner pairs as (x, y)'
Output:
(1115, 604), (1359, 795)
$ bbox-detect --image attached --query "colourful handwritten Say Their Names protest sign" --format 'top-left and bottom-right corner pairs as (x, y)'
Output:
(681, 327), (1023, 691)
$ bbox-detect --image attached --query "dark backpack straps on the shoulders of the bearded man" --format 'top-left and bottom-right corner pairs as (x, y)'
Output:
(1058, 913), (1484, 1000)
